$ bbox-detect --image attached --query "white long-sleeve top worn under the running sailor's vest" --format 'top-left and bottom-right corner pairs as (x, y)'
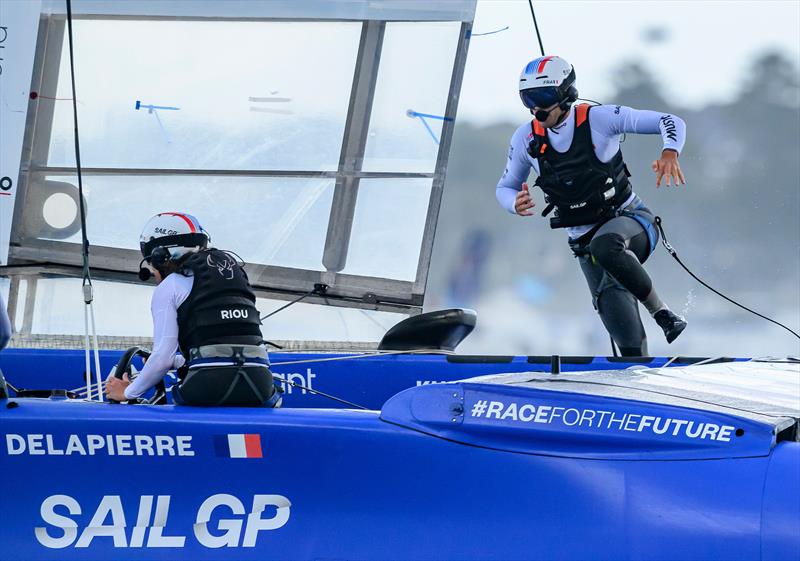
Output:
(495, 105), (686, 239)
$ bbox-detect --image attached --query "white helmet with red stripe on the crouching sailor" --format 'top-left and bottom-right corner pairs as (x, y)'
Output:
(139, 212), (211, 268)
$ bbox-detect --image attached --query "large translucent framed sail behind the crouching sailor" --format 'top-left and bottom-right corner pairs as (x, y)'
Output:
(0, 0), (475, 344)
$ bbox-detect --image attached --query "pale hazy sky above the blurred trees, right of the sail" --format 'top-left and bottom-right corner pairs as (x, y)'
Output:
(459, 0), (800, 123)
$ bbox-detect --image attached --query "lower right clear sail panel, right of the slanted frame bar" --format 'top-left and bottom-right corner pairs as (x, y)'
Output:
(343, 179), (432, 281)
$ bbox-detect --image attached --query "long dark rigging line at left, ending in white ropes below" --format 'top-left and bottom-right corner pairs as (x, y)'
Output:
(66, 0), (103, 401)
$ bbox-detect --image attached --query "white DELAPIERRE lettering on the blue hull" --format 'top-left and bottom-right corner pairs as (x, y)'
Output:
(6, 434), (194, 456)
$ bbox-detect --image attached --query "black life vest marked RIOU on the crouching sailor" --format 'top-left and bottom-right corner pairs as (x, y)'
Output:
(176, 249), (263, 360)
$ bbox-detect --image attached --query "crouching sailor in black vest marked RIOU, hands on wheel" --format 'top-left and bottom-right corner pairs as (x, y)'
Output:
(106, 212), (280, 407)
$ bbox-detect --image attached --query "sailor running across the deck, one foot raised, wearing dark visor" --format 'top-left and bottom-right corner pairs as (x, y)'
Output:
(496, 56), (686, 356)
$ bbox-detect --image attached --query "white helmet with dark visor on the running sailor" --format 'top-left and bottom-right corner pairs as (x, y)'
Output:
(519, 56), (578, 109)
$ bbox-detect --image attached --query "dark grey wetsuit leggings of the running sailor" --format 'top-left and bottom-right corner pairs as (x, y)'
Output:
(573, 201), (655, 356)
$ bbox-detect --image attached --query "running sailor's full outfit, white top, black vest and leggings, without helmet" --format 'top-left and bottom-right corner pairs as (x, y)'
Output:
(497, 105), (685, 356)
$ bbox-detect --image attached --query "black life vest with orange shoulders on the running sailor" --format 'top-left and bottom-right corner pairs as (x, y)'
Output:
(528, 104), (632, 228)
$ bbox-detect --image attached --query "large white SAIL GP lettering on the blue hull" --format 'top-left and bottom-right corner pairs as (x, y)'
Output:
(34, 493), (292, 549)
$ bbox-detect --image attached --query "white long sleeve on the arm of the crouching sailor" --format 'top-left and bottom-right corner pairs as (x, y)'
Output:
(125, 273), (194, 399)
